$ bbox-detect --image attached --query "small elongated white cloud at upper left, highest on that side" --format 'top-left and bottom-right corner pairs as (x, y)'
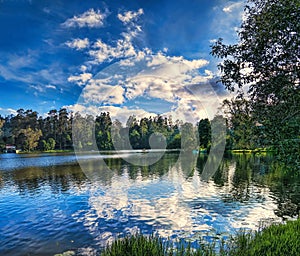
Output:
(62, 9), (107, 28)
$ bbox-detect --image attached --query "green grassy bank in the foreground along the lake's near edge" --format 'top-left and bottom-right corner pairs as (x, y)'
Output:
(100, 219), (300, 256)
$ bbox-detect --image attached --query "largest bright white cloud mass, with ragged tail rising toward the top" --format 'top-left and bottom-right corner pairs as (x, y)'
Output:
(68, 9), (225, 123)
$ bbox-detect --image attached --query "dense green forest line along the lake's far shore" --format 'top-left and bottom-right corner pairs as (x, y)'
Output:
(0, 100), (284, 154)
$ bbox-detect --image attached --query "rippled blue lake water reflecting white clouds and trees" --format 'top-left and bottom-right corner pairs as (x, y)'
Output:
(0, 152), (300, 255)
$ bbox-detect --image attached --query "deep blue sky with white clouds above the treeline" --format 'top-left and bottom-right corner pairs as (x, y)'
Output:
(0, 0), (245, 121)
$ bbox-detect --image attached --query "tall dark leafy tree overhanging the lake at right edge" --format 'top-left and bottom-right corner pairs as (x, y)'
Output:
(212, 0), (300, 164)
